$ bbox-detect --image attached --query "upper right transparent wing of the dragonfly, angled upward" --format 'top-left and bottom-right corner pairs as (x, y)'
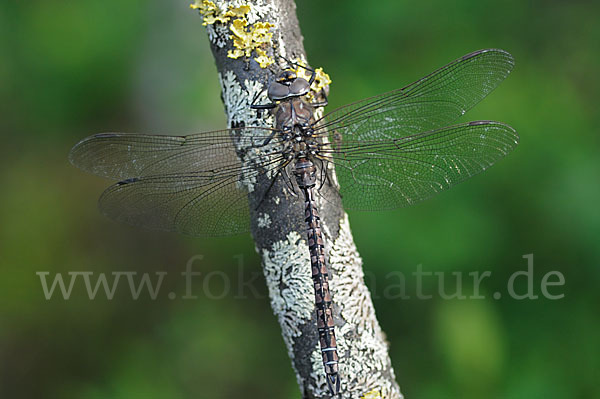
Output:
(316, 49), (514, 141)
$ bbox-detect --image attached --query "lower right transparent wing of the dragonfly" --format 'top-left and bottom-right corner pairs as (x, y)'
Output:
(321, 121), (519, 210)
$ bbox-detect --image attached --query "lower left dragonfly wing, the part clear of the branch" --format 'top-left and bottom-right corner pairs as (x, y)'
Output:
(99, 174), (258, 236)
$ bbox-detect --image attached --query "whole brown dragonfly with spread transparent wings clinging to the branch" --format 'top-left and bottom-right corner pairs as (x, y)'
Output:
(69, 49), (519, 395)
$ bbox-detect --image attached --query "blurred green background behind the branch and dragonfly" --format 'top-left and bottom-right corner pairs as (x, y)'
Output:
(0, 0), (600, 399)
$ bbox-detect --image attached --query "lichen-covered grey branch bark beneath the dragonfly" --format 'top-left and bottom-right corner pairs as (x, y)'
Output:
(196, 0), (402, 398)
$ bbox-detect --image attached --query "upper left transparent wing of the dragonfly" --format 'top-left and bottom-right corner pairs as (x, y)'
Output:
(69, 127), (273, 180)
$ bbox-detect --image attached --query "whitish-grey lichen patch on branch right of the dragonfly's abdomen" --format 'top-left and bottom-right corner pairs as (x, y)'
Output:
(329, 215), (402, 399)
